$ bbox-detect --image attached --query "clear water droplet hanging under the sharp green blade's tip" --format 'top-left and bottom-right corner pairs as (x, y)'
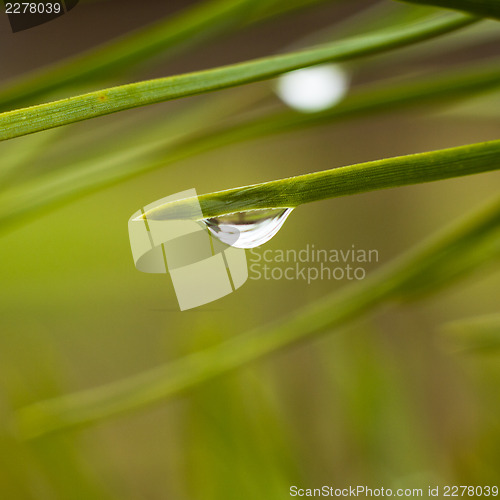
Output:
(203, 208), (293, 248)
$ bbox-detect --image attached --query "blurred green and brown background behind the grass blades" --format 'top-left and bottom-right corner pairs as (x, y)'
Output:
(0, 0), (500, 500)
